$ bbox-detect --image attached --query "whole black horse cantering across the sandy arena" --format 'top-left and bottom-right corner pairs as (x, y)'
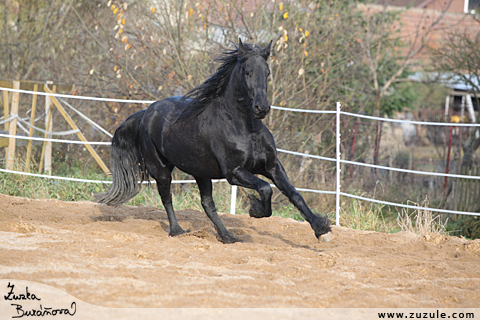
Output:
(97, 40), (330, 243)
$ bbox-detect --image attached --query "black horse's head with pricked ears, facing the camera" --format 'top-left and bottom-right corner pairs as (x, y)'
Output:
(238, 39), (272, 119)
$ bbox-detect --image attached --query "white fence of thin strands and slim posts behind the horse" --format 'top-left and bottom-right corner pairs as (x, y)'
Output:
(0, 87), (480, 225)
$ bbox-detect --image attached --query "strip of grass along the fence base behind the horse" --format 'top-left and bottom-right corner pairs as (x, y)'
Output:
(0, 172), (445, 238)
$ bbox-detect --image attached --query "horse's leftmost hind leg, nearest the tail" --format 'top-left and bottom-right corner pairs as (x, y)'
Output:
(147, 164), (185, 237)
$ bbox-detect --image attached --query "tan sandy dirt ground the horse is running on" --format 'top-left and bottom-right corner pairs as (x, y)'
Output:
(0, 195), (480, 308)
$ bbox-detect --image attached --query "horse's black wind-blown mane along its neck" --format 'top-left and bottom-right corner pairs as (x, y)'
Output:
(176, 44), (262, 121)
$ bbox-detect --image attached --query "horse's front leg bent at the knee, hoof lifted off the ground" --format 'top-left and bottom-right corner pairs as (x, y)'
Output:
(227, 168), (273, 218)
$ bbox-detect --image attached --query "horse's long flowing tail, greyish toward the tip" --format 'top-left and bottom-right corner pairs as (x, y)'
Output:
(95, 110), (148, 206)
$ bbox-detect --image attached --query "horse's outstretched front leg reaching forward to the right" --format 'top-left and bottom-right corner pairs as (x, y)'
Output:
(265, 159), (331, 238)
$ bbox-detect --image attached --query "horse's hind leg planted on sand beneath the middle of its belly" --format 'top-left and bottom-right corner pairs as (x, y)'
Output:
(195, 177), (241, 243)
